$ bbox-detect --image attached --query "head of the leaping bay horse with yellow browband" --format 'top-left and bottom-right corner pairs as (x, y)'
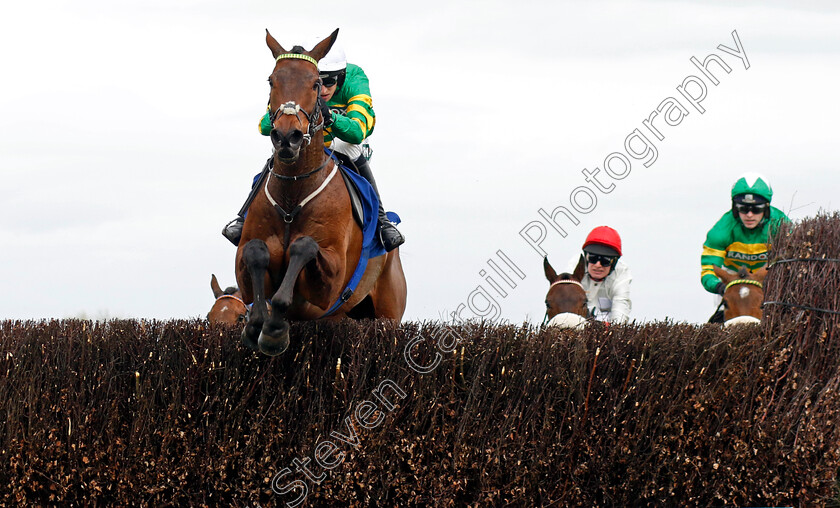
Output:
(265, 29), (338, 164)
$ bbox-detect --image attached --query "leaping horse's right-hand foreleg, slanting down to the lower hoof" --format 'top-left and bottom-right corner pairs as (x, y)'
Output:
(259, 236), (319, 355)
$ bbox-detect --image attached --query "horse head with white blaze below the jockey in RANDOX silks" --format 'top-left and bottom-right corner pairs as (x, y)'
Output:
(714, 266), (767, 326)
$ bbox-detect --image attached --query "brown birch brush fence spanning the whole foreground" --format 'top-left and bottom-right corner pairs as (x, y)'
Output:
(0, 214), (840, 507)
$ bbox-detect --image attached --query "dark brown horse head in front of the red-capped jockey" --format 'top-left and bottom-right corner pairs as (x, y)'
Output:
(543, 257), (589, 328)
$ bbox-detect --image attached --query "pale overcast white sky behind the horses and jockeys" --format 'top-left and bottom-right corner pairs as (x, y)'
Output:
(0, 0), (840, 323)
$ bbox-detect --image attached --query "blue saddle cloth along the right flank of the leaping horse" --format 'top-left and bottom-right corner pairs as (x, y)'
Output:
(321, 148), (400, 317)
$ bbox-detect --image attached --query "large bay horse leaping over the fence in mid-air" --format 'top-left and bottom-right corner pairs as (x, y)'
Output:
(236, 30), (406, 355)
